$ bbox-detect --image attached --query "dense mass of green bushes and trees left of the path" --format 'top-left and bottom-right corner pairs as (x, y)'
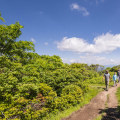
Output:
(0, 19), (105, 120)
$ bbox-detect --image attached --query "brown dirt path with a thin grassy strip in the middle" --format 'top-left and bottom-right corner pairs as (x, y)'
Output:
(62, 85), (120, 120)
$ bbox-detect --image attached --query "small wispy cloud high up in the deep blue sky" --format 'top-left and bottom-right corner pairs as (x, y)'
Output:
(70, 3), (90, 16)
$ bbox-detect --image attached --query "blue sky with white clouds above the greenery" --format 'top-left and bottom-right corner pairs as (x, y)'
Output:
(0, 0), (120, 66)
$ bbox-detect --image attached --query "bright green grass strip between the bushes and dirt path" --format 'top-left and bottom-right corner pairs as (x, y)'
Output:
(43, 85), (103, 120)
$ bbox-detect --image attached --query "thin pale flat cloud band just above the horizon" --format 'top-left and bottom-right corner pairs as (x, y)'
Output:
(62, 55), (119, 65)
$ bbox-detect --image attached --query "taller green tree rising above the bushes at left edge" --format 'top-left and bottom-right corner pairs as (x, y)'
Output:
(0, 22), (34, 62)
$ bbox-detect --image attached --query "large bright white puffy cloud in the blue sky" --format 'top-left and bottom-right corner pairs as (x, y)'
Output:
(57, 33), (120, 54)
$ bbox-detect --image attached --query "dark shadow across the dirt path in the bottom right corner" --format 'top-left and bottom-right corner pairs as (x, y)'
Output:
(100, 107), (120, 120)
